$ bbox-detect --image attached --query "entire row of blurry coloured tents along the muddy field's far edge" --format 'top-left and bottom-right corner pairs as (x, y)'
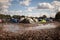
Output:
(0, 18), (53, 23)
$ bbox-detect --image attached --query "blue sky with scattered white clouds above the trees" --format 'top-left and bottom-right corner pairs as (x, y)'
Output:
(0, 0), (60, 17)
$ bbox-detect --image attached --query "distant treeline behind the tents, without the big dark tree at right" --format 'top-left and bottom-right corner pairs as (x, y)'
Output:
(0, 14), (50, 19)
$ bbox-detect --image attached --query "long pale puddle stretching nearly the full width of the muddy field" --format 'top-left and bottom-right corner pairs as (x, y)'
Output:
(3, 23), (56, 33)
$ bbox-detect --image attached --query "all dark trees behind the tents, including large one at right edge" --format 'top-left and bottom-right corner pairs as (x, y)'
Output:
(0, 12), (60, 20)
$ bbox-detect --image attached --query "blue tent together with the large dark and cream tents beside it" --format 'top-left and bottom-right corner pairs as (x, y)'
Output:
(10, 18), (38, 23)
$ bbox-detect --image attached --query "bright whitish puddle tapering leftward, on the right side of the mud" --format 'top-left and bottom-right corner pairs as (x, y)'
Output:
(25, 24), (56, 30)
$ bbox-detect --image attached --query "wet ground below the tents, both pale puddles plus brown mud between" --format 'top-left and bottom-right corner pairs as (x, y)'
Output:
(2, 23), (56, 33)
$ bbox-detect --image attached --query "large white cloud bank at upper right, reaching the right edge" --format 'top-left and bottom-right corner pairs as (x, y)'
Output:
(36, 0), (60, 13)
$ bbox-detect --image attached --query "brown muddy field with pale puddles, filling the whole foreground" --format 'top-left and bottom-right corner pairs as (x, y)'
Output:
(0, 23), (60, 40)
